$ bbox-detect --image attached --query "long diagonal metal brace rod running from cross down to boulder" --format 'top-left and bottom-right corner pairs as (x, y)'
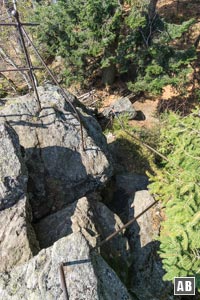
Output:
(22, 27), (85, 151)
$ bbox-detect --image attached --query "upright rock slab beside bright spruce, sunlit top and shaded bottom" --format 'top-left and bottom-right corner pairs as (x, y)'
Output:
(128, 190), (172, 300)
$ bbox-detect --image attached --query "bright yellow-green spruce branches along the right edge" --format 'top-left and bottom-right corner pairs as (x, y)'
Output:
(150, 110), (200, 290)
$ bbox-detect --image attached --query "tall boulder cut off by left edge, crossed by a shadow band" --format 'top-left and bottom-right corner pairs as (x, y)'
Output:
(0, 124), (39, 272)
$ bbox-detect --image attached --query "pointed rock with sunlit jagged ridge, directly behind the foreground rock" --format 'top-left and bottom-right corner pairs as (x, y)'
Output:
(35, 197), (130, 278)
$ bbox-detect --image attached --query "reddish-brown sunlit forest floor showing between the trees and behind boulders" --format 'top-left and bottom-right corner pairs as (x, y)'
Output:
(0, 0), (200, 128)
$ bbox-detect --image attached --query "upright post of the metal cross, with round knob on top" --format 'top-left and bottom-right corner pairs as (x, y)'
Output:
(12, 10), (42, 111)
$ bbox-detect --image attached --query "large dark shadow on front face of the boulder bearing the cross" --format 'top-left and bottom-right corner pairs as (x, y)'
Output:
(26, 146), (88, 218)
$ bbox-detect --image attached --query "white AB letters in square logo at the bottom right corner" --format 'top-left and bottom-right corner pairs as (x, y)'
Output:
(174, 277), (195, 295)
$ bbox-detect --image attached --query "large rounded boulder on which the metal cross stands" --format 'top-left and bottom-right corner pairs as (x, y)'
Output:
(0, 85), (112, 219)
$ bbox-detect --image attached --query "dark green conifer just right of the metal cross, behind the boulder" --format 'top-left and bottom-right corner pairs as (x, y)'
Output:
(30, 0), (121, 83)
